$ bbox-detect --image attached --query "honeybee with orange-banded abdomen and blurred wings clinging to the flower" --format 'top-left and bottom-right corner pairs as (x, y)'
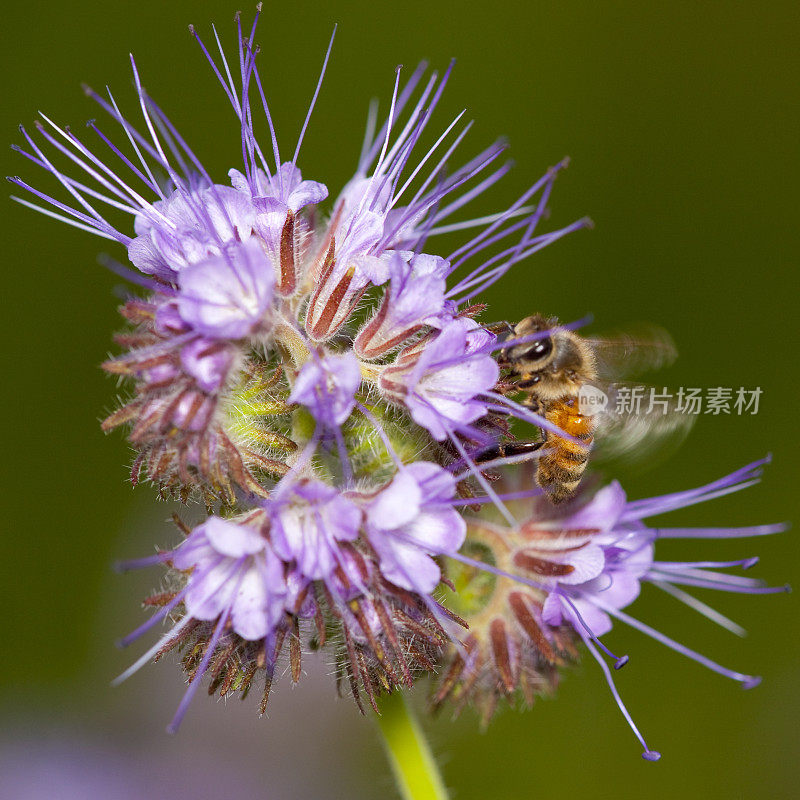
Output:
(488, 314), (692, 504)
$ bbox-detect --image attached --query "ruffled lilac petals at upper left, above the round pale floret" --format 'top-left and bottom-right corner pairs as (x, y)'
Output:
(128, 185), (256, 280)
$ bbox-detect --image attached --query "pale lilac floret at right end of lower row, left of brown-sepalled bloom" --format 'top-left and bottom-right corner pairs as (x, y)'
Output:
(366, 461), (466, 594)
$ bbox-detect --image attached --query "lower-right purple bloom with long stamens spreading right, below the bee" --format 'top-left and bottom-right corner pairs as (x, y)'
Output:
(436, 461), (787, 760)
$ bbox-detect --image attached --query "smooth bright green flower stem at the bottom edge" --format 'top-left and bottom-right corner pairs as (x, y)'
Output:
(377, 692), (447, 800)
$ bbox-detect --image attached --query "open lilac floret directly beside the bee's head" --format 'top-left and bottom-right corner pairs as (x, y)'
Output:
(381, 318), (500, 441)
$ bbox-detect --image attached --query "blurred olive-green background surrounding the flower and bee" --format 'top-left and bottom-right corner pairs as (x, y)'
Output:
(0, 0), (800, 800)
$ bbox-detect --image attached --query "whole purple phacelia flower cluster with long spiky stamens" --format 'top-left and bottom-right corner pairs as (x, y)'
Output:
(11, 7), (788, 758)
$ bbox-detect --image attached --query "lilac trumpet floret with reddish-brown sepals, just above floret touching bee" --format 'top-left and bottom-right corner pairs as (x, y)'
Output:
(354, 252), (449, 358)
